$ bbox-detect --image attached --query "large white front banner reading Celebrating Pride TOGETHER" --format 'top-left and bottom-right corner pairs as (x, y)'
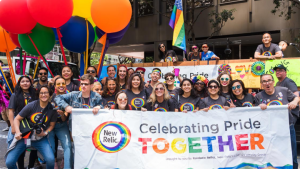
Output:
(72, 106), (293, 169)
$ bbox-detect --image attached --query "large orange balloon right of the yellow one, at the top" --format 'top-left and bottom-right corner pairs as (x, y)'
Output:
(91, 0), (132, 33)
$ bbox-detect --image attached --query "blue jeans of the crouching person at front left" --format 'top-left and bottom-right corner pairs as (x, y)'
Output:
(5, 137), (55, 169)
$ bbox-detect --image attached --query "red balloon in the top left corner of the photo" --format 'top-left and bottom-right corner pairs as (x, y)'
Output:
(0, 0), (36, 34)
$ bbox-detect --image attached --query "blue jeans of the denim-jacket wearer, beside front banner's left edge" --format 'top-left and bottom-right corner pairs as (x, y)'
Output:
(49, 122), (73, 169)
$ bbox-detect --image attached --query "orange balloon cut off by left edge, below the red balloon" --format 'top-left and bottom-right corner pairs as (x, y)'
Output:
(0, 26), (17, 52)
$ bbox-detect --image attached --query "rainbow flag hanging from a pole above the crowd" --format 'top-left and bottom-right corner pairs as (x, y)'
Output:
(169, 0), (186, 51)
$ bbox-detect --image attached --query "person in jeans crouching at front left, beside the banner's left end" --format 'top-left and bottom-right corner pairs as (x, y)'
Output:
(6, 86), (57, 169)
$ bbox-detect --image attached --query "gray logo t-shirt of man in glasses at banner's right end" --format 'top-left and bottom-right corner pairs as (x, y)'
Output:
(255, 86), (299, 124)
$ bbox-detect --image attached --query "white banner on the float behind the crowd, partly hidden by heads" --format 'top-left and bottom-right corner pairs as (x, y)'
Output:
(132, 65), (220, 87)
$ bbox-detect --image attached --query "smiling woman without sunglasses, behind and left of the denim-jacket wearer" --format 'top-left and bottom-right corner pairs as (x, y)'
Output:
(61, 65), (79, 93)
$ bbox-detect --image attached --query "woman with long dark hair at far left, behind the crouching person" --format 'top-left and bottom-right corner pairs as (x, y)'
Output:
(7, 75), (37, 168)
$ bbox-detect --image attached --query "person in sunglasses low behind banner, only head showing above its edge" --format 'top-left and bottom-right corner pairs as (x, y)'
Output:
(110, 91), (132, 110)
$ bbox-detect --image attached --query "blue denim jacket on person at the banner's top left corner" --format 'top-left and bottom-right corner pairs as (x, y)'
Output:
(54, 91), (103, 109)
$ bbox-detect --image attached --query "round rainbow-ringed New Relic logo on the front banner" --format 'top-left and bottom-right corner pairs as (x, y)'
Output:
(92, 121), (131, 153)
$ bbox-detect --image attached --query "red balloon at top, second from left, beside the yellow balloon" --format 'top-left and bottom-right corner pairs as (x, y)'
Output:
(27, 0), (73, 28)
